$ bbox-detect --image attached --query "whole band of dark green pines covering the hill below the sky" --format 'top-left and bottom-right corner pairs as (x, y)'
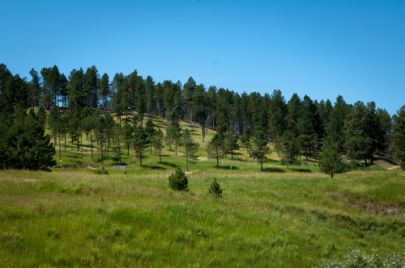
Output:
(0, 64), (405, 172)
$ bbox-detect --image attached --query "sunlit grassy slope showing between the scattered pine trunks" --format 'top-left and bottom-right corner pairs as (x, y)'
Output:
(47, 116), (312, 173)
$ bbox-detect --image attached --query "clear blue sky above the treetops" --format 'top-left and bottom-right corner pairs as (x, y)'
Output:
(0, 0), (405, 113)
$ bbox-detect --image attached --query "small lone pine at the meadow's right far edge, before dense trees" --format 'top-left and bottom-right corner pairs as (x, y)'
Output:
(318, 138), (345, 178)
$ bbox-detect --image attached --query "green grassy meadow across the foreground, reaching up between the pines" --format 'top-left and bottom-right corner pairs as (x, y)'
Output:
(0, 118), (405, 267)
